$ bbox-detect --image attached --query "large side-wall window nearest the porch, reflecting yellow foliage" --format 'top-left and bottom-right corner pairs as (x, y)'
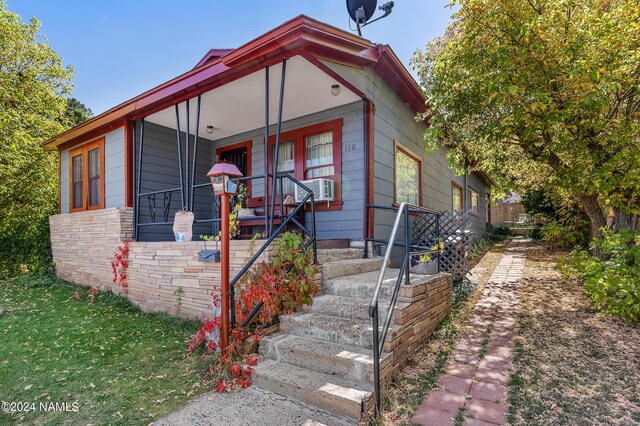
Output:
(394, 142), (422, 205)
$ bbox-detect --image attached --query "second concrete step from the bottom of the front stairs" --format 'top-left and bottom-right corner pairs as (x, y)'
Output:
(260, 333), (391, 382)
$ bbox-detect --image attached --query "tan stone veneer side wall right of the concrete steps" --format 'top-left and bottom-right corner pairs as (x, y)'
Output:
(380, 274), (453, 382)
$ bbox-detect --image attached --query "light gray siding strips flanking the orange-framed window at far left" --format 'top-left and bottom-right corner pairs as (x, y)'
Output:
(60, 127), (125, 213)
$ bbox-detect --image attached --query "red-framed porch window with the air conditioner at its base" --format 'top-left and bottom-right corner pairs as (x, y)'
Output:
(269, 119), (342, 210)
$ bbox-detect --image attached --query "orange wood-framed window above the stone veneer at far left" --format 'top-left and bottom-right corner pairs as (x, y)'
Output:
(69, 138), (104, 212)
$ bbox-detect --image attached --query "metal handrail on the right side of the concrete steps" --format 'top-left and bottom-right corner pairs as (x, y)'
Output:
(365, 203), (440, 414)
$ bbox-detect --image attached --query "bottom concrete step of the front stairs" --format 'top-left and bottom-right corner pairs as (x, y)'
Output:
(252, 360), (373, 421)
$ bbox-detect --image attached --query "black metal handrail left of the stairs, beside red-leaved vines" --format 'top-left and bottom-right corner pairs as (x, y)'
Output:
(229, 175), (318, 328)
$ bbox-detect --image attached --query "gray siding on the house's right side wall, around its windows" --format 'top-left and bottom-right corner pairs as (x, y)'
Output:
(326, 62), (488, 243)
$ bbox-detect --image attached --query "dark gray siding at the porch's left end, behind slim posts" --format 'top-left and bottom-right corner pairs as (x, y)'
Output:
(136, 122), (214, 241)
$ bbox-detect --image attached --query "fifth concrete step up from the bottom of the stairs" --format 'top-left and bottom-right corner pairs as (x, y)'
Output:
(322, 269), (433, 302)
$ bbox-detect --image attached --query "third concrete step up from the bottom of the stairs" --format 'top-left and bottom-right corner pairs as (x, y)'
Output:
(280, 313), (397, 349)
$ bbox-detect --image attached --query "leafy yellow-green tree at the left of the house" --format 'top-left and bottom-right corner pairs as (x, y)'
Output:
(0, 0), (72, 276)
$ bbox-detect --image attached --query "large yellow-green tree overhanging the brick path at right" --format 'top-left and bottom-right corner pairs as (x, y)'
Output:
(413, 0), (640, 238)
